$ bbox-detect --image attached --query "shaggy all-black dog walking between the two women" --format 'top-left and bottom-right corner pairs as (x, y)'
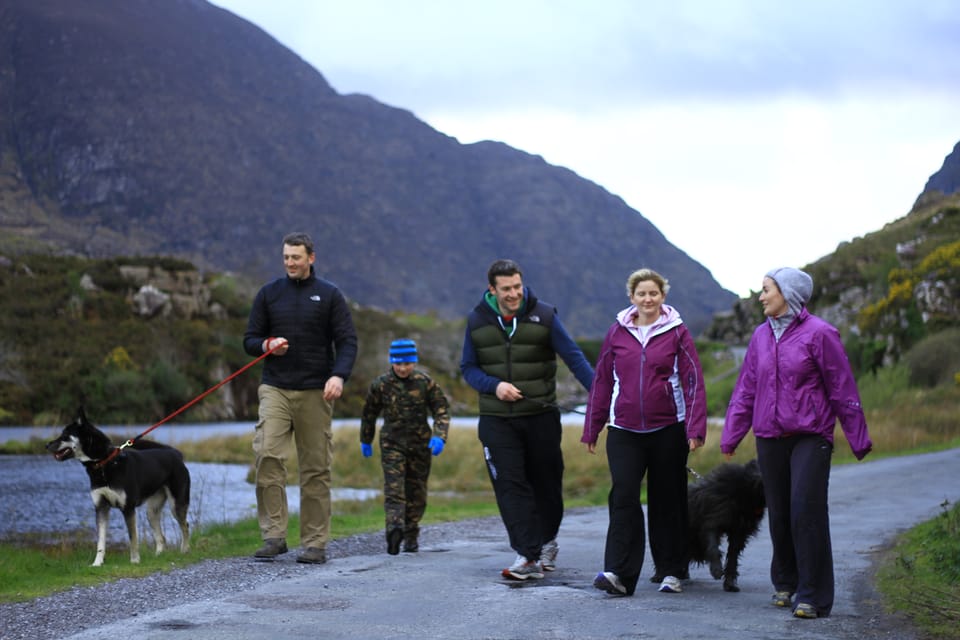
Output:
(687, 460), (767, 591)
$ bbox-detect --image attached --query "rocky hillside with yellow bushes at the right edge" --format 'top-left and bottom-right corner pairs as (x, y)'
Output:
(704, 172), (960, 382)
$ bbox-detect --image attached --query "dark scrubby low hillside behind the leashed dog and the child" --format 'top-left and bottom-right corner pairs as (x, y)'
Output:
(0, 254), (476, 425)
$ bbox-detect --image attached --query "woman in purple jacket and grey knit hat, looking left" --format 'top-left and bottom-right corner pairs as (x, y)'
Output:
(720, 267), (873, 618)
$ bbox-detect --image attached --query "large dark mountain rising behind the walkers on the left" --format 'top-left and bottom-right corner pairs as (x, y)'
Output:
(0, 0), (736, 336)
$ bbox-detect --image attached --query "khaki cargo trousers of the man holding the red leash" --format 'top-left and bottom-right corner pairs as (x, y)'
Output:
(253, 384), (333, 549)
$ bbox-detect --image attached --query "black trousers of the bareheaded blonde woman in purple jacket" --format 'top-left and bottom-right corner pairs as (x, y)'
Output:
(603, 422), (690, 594)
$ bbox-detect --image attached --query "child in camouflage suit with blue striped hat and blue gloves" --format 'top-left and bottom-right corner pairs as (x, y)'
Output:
(360, 340), (450, 555)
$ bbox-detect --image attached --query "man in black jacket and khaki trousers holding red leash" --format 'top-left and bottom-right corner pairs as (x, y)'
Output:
(243, 233), (357, 564)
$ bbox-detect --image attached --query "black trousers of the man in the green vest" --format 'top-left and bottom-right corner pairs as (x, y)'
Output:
(478, 410), (563, 560)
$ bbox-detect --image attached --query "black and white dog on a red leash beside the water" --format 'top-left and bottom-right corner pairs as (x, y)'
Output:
(47, 409), (190, 567)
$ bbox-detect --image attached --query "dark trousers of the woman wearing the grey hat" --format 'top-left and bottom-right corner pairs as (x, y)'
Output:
(757, 435), (834, 616)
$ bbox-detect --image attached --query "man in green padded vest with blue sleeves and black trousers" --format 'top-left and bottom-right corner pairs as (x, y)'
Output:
(460, 260), (593, 580)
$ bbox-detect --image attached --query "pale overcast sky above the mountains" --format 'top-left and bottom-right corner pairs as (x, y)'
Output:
(214, 0), (960, 296)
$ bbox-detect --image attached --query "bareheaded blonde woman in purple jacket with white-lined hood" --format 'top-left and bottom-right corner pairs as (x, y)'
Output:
(580, 269), (707, 595)
